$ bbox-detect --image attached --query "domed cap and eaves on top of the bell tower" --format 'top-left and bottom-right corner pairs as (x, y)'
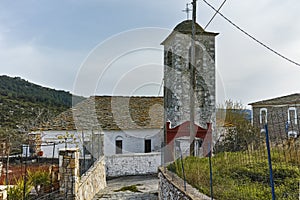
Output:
(161, 20), (219, 45)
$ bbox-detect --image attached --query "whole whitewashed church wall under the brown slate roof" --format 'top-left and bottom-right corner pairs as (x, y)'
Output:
(29, 129), (163, 158)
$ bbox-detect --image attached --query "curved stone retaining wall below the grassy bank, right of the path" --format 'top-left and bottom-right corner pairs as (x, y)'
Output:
(158, 168), (211, 200)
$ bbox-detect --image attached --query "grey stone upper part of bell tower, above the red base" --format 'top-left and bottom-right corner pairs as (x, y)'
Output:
(162, 20), (218, 133)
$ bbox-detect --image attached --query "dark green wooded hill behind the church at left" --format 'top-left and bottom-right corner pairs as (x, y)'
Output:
(0, 75), (84, 130)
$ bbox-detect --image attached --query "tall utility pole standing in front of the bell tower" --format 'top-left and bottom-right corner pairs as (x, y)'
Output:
(190, 0), (197, 156)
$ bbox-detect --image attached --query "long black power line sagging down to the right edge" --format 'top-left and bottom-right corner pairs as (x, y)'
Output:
(203, 0), (300, 67)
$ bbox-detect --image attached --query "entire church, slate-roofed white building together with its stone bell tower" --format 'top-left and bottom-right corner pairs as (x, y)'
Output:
(27, 17), (218, 175)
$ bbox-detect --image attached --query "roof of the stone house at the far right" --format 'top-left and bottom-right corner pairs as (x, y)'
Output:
(249, 93), (300, 106)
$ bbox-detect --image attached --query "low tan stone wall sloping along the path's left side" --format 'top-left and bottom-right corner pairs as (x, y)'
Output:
(76, 157), (106, 200)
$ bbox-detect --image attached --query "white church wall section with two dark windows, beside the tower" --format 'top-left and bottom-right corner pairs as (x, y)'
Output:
(104, 129), (163, 156)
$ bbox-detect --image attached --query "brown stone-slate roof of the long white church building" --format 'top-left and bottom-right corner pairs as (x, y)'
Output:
(41, 96), (164, 130)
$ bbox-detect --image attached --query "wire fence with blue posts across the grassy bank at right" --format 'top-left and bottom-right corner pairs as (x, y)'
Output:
(168, 107), (300, 200)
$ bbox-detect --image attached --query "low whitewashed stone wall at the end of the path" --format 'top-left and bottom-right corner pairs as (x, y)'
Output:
(105, 152), (161, 177)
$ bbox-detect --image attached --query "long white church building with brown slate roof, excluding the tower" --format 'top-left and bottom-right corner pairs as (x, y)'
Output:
(34, 96), (163, 176)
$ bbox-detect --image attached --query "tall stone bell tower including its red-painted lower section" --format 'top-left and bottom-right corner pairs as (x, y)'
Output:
(161, 20), (218, 162)
